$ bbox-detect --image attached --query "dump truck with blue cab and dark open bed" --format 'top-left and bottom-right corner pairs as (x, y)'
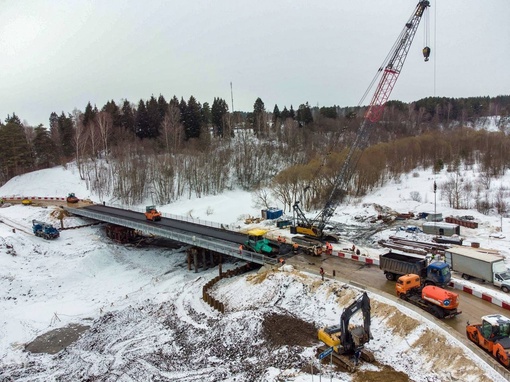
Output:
(379, 251), (451, 287)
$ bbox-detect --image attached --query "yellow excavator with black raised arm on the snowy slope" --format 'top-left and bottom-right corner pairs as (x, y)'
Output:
(318, 292), (375, 372)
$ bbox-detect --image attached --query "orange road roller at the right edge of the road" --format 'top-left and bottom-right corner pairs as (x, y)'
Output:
(466, 314), (510, 368)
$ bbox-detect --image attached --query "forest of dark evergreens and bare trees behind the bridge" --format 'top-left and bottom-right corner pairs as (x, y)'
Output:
(0, 95), (510, 213)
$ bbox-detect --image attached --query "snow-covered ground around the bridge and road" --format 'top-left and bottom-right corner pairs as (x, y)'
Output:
(0, 166), (510, 381)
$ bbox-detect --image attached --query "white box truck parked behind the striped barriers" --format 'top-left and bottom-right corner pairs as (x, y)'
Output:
(444, 247), (510, 293)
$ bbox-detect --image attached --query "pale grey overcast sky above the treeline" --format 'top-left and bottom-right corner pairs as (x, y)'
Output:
(0, 0), (510, 126)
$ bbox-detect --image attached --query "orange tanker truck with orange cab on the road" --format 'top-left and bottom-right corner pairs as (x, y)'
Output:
(395, 274), (462, 319)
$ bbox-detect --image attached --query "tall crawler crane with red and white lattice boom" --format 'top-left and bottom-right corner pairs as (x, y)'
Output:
(291, 0), (430, 241)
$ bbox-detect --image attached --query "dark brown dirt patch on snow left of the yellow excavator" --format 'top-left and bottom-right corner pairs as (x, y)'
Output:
(262, 313), (317, 346)
